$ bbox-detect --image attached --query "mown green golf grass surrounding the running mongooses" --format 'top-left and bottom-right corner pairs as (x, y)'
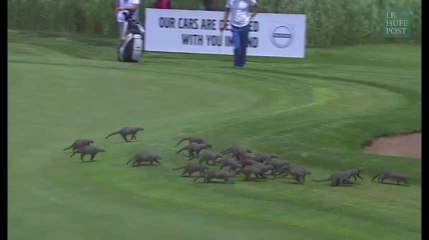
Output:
(8, 31), (421, 240)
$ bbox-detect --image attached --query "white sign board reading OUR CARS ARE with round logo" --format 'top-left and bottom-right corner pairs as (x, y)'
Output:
(145, 8), (306, 58)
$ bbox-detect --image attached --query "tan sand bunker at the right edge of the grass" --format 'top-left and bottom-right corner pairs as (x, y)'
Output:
(363, 133), (422, 159)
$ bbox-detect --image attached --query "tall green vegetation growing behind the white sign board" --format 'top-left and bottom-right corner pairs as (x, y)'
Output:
(8, 0), (421, 47)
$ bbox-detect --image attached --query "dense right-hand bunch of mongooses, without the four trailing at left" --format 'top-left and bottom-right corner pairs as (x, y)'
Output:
(173, 137), (408, 186)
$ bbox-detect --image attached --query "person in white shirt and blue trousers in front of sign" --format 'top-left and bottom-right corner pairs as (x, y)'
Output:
(220, 0), (260, 68)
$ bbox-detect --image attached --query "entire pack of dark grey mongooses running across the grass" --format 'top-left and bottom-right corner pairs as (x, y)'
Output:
(63, 133), (409, 186)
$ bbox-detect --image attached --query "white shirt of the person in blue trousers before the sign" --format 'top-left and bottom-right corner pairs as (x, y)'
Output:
(225, 0), (258, 27)
